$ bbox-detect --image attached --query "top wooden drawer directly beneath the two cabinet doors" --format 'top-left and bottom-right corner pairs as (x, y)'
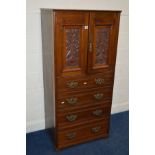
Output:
(56, 73), (113, 92)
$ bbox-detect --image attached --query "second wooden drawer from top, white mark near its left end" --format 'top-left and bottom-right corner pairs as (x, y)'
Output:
(56, 87), (112, 110)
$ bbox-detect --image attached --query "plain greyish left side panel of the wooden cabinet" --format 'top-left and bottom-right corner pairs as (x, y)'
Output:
(41, 10), (55, 128)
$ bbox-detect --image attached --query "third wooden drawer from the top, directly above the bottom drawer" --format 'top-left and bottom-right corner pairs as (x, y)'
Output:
(57, 106), (111, 130)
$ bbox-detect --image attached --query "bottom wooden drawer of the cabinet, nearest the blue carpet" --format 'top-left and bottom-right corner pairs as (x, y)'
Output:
(57, 119), (109, 147)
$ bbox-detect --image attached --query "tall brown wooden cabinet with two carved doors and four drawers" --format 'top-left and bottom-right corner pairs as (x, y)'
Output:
(41, 9), (121, 149)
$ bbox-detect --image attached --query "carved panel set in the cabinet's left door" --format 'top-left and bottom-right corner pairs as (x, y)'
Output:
(65, 29), (80, 67)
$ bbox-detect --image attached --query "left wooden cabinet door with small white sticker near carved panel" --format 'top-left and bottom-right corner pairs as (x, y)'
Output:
(55, 11), (89, 76)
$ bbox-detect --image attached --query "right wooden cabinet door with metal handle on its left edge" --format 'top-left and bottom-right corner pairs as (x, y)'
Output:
(88, 12), (120, 73)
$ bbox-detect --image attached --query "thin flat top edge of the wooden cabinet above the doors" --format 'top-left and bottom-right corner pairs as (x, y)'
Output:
(40, 8), (122, 13)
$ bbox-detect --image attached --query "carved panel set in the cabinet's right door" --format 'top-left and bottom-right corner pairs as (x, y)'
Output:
(96, 28), (110, 65)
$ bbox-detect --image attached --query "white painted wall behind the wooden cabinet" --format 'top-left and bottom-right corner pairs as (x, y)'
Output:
(26, 0), (129, 132)
